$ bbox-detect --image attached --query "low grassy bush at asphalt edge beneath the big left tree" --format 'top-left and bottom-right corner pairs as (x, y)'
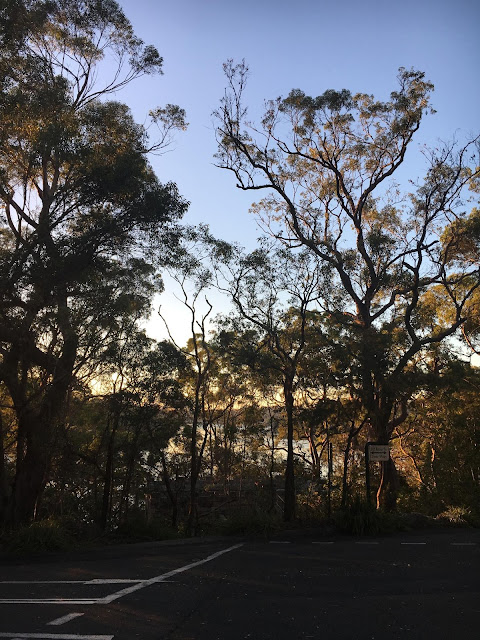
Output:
(5, 520), (73, 555)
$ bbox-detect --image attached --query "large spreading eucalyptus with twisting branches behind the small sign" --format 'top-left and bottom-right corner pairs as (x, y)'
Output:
(216, 61), (480, 508)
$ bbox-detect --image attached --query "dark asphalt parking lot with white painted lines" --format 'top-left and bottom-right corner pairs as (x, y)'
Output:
(0, 529), (480, 640)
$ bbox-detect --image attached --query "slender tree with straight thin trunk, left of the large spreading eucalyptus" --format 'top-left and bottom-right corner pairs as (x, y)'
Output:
(219, 242), (322, 521)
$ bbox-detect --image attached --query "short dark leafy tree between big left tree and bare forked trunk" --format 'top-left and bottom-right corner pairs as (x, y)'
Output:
(94, 325), (187, 528)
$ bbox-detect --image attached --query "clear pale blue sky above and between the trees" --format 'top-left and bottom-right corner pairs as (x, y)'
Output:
(111, 0), (480, 348)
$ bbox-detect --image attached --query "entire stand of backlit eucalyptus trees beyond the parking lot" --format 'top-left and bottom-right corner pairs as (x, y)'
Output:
(0, 16), (480, 534)
